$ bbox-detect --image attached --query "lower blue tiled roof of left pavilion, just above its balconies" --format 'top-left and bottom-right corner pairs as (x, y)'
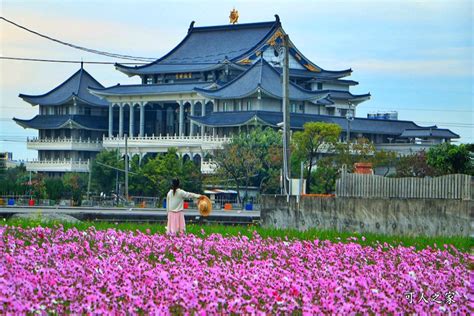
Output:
(13, 115), (109, 131)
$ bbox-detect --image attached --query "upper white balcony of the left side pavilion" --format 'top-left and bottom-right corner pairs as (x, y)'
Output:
(27, 138), (102, 151)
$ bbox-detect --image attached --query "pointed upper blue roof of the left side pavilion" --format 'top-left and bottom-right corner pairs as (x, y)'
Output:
(19, 67), (108, 106)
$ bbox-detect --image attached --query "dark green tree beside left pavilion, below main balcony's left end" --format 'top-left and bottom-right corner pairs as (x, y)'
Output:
(91, 150), (125, 194)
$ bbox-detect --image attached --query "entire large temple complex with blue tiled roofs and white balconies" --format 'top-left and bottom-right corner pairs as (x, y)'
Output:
(15, 15), (459, 172)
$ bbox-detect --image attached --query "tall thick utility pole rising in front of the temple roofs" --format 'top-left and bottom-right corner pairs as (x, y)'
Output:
(282, 34), (291, 195)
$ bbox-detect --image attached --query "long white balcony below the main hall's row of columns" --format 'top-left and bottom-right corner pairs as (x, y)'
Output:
(102, 135), (231, 155)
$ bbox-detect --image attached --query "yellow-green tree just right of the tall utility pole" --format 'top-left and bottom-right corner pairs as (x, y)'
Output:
(293, 122), (341, 192)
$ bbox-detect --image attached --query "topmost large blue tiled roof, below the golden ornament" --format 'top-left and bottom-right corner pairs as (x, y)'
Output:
(115, 15), (352, 79)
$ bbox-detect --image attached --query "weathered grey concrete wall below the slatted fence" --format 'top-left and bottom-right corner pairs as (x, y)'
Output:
(261, 195), (474, 236)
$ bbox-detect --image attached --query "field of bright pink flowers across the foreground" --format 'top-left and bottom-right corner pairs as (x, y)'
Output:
(0, 226), (472, 315)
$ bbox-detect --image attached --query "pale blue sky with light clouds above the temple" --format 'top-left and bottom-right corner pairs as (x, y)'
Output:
(0, 0), (474, 159)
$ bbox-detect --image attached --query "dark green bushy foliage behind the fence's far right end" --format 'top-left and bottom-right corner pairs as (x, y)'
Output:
(426, 143), (474, 175)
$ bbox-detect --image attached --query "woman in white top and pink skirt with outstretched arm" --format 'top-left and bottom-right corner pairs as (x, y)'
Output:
(166, 179), (201, 234)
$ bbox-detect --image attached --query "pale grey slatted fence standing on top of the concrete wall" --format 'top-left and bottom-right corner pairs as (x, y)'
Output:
(336, 172), (474, 200)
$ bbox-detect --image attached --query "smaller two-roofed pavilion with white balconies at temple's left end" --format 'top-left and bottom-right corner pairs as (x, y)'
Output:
(14, 66), (108, 175)
